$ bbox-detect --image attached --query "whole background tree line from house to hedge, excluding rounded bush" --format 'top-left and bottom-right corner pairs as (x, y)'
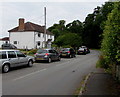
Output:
(48, 2), (114, 48)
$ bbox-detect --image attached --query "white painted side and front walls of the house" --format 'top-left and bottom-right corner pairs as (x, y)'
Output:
(10, 32), (54, 49)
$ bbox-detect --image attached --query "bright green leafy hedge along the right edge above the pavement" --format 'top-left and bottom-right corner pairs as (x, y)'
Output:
(101, 2), (120, 64)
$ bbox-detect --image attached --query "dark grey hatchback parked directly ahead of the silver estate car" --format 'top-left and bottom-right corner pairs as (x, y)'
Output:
(35, 49), (61, 63)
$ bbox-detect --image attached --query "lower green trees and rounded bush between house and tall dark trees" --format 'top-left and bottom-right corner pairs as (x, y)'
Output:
(48, 20), (83, 47)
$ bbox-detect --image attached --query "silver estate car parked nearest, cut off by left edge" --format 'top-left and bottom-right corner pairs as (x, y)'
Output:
(0, 50), (35, 73)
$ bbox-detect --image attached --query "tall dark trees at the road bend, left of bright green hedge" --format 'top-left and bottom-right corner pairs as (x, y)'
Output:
(83, 2), (113, 48)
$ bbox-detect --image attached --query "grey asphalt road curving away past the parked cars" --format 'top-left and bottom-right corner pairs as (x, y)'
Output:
(2, 50), (99, 95)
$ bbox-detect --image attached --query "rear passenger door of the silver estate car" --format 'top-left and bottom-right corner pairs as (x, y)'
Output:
(7, 51), (19, 67)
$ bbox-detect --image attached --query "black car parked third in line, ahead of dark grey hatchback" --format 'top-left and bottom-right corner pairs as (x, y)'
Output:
(60, 48), (76, 58)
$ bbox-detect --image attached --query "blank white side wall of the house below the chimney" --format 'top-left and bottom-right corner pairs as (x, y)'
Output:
(10, 32), (35, 49)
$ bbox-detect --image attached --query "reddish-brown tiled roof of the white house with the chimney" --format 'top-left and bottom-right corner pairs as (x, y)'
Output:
(8, 22), (52, 34)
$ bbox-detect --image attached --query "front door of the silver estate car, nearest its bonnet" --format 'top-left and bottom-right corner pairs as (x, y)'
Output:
(16, 51), (28, 66)
